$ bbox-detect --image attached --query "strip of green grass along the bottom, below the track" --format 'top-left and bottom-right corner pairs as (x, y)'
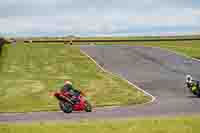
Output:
(0, 116), (200, 133)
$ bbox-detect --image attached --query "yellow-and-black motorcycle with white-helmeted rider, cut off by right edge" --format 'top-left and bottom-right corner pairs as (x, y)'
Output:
(186, 75), (200, 97)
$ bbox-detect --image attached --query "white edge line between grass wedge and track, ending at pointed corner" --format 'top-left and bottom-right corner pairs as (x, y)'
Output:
(80, 48), (156, 104)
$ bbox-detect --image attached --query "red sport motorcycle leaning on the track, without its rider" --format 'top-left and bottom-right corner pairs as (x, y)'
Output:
(53, 92), (92, 113)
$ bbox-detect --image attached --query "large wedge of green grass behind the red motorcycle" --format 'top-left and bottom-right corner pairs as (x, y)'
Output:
(0, 44), (150, 112)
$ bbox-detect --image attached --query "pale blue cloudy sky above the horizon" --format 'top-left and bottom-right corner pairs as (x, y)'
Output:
(0, 0), (200, 36)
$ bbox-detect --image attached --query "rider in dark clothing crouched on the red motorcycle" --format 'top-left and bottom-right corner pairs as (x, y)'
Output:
(60, 80), (81, 103)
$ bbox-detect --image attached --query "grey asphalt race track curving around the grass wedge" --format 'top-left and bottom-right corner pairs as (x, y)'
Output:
(0, 45), (200, 122)
